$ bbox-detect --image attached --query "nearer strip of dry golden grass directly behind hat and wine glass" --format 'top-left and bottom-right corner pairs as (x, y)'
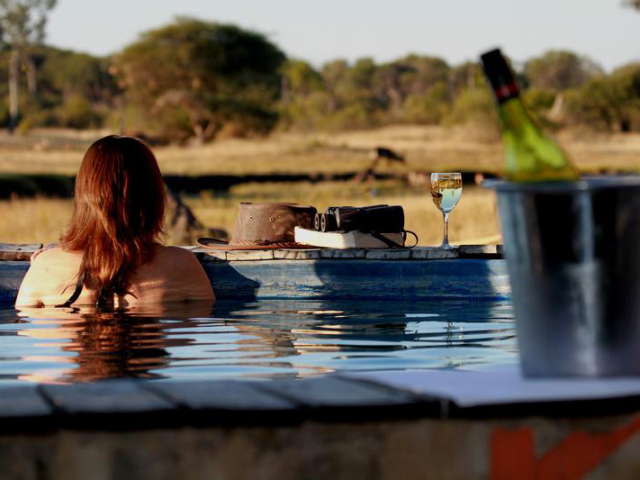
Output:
(0, 184), (498, 245)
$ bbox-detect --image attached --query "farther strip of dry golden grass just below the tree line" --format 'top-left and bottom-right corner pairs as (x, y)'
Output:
(0, 126), (640, 175)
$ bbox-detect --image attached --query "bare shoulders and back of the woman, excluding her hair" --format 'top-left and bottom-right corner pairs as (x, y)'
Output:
(16, 245), (214, 307)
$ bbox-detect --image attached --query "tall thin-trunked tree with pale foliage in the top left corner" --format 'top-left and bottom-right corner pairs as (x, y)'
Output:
(0, 0), (56, 132)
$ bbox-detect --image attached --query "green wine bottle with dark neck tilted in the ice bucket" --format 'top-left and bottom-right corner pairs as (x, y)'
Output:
(480, 49), (579, 182)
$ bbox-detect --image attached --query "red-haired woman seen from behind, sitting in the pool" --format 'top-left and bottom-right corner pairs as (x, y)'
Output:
(16, 135), (214, 307)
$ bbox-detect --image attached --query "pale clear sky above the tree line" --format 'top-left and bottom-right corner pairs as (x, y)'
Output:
(46, 0), (640, 71)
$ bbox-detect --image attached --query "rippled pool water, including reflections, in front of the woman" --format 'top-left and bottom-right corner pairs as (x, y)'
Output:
(0, 300), (518, 386)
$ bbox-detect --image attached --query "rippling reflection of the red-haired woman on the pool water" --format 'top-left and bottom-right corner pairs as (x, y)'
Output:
(18, 302), (212, 383)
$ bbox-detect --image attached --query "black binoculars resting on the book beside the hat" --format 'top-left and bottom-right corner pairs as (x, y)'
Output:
(313, 205), (404, 233)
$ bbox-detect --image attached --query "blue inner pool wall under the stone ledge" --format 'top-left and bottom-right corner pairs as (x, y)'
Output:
(0, 259), (510, 307)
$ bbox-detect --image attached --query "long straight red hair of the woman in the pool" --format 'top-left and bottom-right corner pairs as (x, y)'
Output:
(60, 135), (165, 297)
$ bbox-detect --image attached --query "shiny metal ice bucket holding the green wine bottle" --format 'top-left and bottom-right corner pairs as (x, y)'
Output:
(488, 176), (640, 377)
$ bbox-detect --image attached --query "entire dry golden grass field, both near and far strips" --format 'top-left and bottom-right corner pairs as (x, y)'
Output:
(0, 126), (640, 245)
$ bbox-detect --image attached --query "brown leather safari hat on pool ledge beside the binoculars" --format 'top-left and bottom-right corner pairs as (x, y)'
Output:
(197, 202), (317, 250)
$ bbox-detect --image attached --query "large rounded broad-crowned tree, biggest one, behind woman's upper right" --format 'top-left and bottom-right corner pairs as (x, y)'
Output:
(112, 17), (285, 142)
